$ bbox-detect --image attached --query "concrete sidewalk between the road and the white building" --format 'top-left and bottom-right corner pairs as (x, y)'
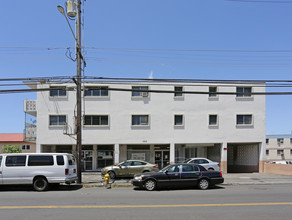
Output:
(82, 172), (292, 187)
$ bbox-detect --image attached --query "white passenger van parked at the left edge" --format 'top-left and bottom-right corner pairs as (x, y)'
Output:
(0, 153), (77, 191)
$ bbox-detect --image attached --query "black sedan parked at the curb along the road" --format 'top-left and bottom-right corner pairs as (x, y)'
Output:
(132, 164), (224, 191)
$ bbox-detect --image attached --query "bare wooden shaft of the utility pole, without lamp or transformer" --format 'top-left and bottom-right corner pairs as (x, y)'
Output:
(76, 0), (82, 183)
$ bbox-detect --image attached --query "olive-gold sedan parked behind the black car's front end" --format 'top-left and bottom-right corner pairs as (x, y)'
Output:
(101, 160), (159, 179)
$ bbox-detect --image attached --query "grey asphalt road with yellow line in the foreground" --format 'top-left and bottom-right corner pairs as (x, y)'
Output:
(0, 184), (292, 220)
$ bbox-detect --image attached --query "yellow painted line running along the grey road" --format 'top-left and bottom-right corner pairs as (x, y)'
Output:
(0, 202), (292, 210)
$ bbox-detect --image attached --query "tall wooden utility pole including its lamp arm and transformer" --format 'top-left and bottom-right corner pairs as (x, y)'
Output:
(57, 0), (85, 183)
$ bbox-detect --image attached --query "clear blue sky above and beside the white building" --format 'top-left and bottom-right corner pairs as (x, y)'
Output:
(0, 0), (292, 134)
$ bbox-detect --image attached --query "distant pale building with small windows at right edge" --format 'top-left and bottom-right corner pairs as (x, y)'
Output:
(266, 134), (292, 161)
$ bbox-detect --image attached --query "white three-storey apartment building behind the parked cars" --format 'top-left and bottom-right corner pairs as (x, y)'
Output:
(24, 81), (266, 172)
